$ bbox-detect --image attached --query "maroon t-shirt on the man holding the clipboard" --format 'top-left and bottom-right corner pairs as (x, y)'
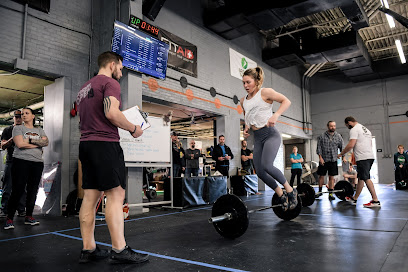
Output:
(76, 75), (121, 142)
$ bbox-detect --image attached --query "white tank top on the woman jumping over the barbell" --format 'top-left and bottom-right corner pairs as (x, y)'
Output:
(242, 88), (273, 128)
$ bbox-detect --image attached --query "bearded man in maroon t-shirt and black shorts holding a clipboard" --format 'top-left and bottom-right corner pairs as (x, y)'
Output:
(76, 52), (149, 263)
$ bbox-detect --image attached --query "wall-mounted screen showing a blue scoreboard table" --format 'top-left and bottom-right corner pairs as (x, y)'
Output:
(112, 21), (169, 79)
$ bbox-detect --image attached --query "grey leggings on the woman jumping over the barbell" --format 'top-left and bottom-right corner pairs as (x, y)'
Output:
(254, 127), (286, 190)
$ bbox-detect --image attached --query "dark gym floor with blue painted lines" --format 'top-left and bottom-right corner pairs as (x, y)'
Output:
(0, 185), (408, 272)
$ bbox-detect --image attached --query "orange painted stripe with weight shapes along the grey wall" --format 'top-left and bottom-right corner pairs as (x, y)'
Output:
(142, 78), (312, 130)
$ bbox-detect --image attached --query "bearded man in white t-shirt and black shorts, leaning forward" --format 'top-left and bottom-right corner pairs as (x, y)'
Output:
(337, 116), (381, 208)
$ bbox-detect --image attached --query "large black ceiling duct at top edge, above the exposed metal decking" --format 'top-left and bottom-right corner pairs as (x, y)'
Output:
(203, 0), (368, 40)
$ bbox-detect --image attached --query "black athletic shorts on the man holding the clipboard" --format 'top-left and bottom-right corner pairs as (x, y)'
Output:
(79, 141), (126, 191)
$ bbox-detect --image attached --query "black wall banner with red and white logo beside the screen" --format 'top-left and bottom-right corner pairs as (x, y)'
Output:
(158, 29), (197, 77)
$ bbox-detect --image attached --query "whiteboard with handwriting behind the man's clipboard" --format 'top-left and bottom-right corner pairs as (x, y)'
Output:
(119, 116), (170, 163)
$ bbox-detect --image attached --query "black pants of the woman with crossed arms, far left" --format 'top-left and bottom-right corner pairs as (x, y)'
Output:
(7, 158), (44, 219)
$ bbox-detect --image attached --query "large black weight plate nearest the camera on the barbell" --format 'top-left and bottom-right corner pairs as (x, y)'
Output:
(211, 194), (249, 239)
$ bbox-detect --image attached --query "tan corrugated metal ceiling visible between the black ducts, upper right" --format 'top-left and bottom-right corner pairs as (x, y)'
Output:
(261, 0), (408, 71)
